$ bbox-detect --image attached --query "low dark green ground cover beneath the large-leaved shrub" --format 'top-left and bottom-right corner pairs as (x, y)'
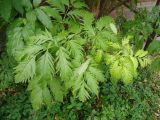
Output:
(0, 70), (160, 120)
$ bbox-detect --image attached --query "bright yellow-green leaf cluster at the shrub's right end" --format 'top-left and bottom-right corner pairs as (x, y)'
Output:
(106, 37), (150, 85)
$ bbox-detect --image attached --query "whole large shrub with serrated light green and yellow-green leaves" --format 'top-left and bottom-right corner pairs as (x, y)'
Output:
(3, 0), (152, 110)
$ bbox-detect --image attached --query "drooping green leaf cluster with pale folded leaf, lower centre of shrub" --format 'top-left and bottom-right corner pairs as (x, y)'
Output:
(73, 59), (104, 102)
